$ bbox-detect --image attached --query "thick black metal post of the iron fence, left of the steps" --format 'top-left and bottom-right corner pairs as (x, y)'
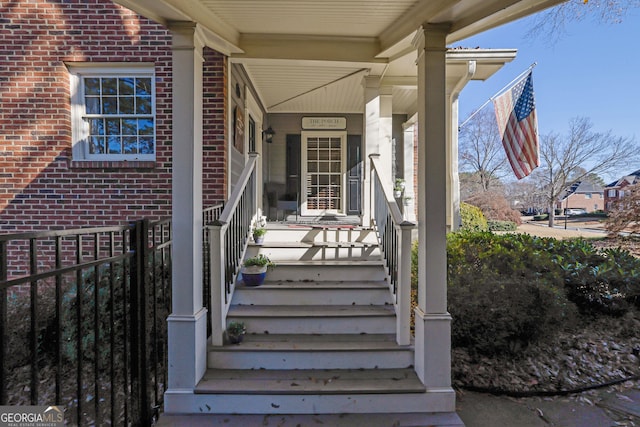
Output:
(129, 219), (149, 425)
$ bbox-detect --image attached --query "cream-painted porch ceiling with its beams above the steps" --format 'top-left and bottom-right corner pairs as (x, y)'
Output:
(115, 0), (564, 114)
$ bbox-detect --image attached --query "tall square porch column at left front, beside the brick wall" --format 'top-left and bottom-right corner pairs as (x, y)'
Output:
(165, 22), (207, 412)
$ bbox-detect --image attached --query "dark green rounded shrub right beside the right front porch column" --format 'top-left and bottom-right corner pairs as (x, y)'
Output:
(447, 232), (576, 355)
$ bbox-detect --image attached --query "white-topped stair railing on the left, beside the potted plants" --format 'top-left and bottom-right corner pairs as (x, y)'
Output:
(208, 153), (258, 346)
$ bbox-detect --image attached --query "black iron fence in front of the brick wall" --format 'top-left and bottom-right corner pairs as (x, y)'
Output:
(0, 220), (171, 426)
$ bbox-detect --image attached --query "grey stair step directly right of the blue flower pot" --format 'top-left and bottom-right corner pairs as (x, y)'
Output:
(267, 260), (386, 281)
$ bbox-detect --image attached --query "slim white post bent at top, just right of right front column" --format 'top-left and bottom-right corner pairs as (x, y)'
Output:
(447, 61), (476, 231)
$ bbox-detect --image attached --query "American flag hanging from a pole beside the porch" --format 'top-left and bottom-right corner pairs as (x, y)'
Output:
(493, 71), (540, 179)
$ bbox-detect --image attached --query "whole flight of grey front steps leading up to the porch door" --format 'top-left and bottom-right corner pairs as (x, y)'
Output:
(190, 227), (462, 426)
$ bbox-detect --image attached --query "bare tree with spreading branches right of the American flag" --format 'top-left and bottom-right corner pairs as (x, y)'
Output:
(536, 117), (640, 227)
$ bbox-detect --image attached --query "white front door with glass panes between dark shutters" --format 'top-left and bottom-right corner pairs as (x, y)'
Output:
(301, 132), (347, 215)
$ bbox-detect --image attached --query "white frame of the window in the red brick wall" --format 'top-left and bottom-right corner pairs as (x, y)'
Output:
(67, 63), (158, 161)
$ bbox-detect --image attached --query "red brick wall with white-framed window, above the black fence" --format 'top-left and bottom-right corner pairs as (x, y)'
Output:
(0, 0), (227, 233)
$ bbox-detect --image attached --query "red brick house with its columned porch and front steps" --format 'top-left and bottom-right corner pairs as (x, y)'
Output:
(0, 0), (560, 425)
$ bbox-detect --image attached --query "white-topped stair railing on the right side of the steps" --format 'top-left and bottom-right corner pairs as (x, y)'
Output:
(369, 154), (415, 345)
